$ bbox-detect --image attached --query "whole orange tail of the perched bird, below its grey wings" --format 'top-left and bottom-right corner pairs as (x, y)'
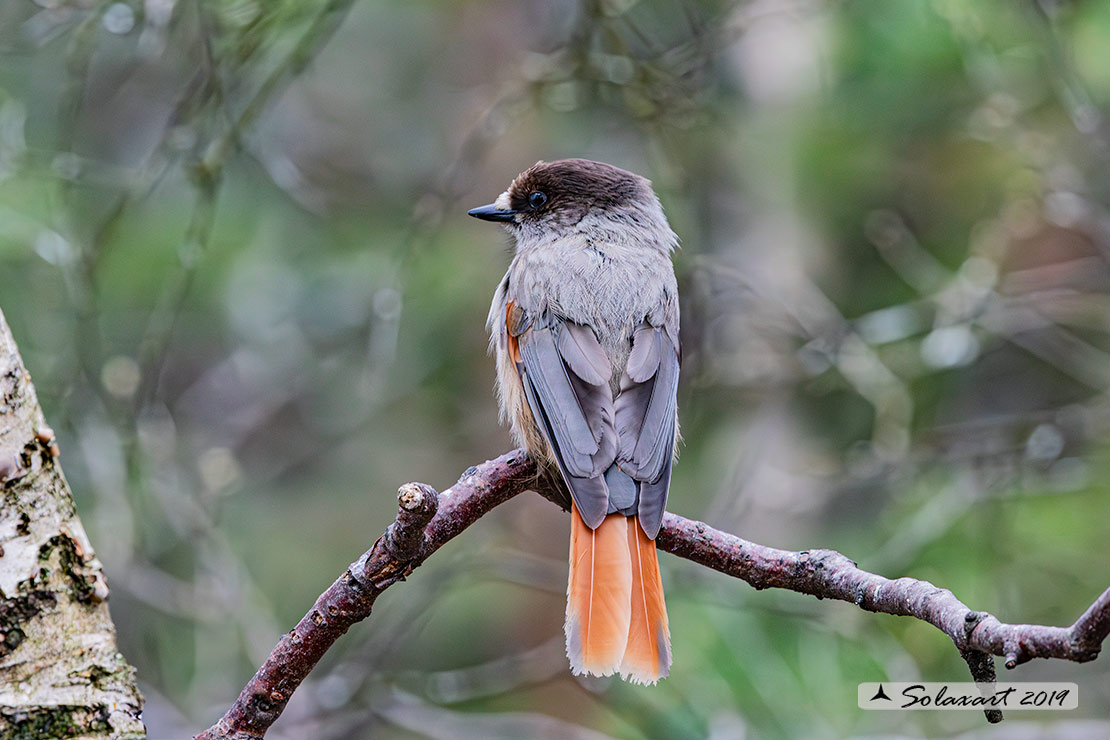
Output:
(566, 507), (670, 683)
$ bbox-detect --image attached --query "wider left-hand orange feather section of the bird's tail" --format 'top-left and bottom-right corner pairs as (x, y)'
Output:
(566, 506), (633, 676)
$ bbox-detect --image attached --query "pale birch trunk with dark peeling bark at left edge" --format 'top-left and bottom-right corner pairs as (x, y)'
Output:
(0, 313), (147, 740)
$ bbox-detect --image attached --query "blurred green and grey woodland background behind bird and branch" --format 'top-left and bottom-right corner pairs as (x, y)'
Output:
(0, 0), (1110, 740)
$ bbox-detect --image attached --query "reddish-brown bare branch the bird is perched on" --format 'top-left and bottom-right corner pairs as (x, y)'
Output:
(195, 449), (1110, 740)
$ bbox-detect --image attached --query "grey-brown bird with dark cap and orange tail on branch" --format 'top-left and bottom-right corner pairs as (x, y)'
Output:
(468, 159), (682, 685)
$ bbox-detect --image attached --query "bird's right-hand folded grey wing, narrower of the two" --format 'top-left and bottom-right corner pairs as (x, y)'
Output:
(614, 323), (679, 539)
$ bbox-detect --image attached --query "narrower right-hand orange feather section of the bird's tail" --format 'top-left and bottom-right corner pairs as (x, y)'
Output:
(620, 517), (670, 683)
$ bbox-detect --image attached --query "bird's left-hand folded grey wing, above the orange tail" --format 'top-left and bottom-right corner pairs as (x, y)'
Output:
(516, 316), (618, 528)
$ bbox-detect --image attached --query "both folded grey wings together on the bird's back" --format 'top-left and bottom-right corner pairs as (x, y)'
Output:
(506, 311), (679, 539)
